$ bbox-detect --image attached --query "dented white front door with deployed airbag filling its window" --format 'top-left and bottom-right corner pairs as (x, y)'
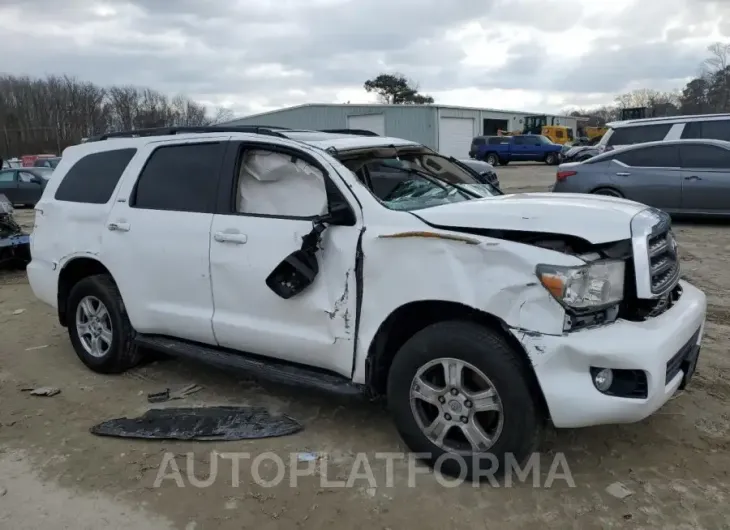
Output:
(210, 144), (360, 376)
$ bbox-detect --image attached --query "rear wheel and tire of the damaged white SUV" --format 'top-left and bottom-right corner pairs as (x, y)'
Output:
(67, 274), (140, 374)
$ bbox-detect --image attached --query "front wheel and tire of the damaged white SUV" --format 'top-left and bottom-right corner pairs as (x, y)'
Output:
(388, 321), (542, 480)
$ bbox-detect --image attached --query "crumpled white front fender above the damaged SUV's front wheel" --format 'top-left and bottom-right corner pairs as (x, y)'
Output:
(353, 225), (584, 383)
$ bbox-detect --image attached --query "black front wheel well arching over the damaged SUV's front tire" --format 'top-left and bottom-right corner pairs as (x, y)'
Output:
(366, 300), (548, 417)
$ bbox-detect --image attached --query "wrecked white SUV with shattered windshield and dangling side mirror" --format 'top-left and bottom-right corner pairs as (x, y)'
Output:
(28, 127), (706, 477)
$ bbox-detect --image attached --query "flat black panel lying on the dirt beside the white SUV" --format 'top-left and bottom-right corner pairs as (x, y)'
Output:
(91, 407), (302, 441)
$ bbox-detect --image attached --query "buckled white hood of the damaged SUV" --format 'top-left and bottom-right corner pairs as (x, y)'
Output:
(413, 193), (648, 244)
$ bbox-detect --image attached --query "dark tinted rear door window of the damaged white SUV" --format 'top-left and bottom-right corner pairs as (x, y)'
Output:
(130, 142), (225, 213)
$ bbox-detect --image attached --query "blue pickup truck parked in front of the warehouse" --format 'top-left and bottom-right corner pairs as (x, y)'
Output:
(469, 134), (563, 166)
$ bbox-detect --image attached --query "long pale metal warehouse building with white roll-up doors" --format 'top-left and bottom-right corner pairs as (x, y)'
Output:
(226, 103), (577, 158)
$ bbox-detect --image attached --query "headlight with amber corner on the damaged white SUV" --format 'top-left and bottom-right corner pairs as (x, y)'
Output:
(536, 260), (626, 309)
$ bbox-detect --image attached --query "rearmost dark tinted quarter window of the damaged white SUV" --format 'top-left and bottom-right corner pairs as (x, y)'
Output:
(55, 148), (137, 204)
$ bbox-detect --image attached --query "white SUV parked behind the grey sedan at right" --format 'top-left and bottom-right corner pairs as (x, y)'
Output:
(597, 114), (730, 153)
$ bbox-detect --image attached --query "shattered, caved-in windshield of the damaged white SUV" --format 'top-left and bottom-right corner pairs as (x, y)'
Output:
(345, 152), (500, 211)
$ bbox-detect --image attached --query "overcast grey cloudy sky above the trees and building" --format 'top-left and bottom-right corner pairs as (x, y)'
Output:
(0, 0), (730, 115)
